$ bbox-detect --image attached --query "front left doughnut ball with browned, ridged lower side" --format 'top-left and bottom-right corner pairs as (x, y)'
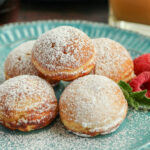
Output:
(0, 75), (58, 131)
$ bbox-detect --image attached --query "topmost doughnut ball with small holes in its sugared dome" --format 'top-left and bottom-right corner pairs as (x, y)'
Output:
(32, 26), (95, 81)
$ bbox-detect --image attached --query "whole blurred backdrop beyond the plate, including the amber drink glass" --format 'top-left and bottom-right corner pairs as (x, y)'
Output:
(0, 0), (150, 36)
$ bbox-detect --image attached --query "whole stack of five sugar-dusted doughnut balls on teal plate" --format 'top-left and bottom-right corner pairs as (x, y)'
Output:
(0, 26), (134, 136)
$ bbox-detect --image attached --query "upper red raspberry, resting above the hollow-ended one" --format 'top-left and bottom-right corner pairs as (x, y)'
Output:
(133, 54), (150, 75)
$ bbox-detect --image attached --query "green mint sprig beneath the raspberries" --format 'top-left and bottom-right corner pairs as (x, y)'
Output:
(118, 80), (150, 111)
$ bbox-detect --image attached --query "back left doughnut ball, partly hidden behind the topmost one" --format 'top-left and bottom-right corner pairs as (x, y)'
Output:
(4, 40), (58, 85)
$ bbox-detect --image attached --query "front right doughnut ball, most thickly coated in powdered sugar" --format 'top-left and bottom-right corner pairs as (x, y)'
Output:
(59, 75), (128, 137)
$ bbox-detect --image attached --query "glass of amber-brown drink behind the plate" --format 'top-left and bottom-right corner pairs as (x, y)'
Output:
(109, 0), (150, 36)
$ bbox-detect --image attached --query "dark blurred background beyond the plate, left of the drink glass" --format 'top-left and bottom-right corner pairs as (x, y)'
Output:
(0, 0), (108, 25)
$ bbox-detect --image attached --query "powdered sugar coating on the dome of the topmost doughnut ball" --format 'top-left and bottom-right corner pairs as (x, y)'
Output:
(33, 26), (95, 71)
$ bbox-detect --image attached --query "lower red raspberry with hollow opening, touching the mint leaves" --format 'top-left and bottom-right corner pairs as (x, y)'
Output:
(130, 71), (150, 97)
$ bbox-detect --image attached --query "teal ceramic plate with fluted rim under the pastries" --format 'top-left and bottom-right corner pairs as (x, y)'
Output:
(0, 21), (150, 150)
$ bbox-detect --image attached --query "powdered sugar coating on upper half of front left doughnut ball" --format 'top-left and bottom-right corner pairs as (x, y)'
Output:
(0, 75), (56, 117)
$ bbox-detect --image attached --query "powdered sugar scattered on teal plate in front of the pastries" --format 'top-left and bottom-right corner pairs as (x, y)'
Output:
(0, 110), (150, 150)
